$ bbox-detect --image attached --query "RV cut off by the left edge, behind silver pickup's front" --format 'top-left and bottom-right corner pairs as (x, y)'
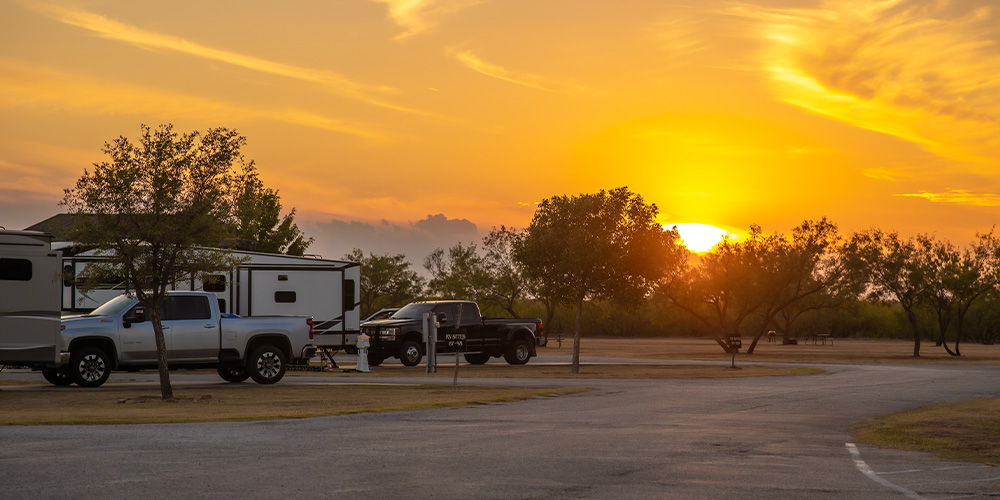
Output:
(0, 230), (62, 366)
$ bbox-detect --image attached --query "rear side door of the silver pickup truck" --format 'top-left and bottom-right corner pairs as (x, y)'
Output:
(164, 295), (220, 362)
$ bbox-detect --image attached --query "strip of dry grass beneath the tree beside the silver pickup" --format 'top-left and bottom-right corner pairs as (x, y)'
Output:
(0, 384), (591, 425)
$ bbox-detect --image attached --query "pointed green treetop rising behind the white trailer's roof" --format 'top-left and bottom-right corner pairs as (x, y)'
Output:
(233, 174), (313, 255)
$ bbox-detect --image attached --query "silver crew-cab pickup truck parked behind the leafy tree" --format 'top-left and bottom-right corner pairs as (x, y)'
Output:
(47, 292), (316, 387)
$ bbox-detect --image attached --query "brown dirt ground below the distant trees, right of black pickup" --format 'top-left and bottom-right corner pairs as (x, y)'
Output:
(538, 337), (1000, 365)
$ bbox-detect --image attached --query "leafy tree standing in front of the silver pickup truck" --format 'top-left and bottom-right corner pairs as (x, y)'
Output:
(61, 125), (256, 399)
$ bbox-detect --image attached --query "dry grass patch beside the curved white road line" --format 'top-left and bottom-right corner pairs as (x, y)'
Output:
(851, 399), (1000, 465)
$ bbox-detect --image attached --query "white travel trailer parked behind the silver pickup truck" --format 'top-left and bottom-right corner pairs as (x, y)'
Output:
(62, 251), (361, 350)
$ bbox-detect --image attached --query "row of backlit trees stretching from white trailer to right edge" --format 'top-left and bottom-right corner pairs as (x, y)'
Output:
(345, 188), (1000, 356)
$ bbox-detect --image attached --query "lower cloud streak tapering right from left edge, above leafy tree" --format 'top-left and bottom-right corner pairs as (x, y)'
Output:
(0, 59), (385, 140)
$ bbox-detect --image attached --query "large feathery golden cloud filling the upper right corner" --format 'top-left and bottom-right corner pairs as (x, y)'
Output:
(729, 0), (1000, 161)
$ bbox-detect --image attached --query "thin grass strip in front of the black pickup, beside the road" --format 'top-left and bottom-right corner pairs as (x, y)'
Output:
(286, 358), (825, 379)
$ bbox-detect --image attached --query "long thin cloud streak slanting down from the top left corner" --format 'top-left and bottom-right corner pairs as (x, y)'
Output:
(25, 3), (418, 113)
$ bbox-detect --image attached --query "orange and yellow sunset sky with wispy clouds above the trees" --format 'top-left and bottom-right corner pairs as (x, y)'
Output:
(0, 0), (1000, 267)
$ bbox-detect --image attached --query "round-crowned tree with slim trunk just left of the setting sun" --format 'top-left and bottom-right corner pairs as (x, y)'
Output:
(514, 187), (679, 373)
